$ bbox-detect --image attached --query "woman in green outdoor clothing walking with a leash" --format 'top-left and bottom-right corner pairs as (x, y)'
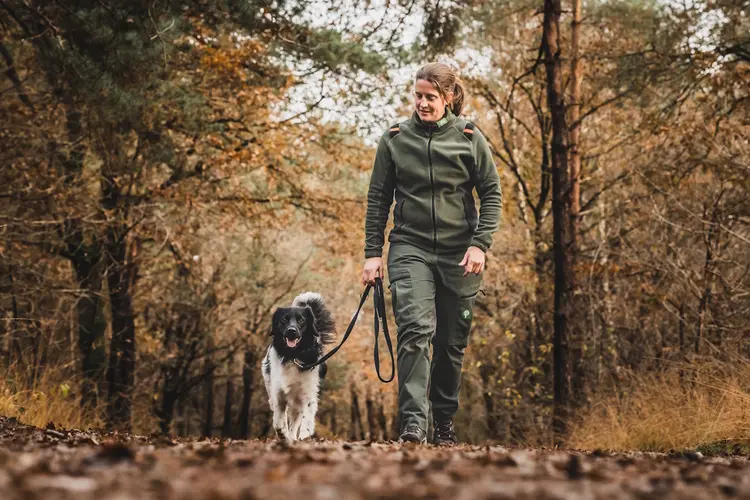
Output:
(362, 63), (502, 445)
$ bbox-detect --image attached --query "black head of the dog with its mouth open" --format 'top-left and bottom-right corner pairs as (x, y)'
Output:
(271, 307), (319, 358)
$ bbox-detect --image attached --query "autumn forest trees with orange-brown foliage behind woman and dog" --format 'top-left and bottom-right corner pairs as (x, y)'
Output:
(0, 0), (750, 447)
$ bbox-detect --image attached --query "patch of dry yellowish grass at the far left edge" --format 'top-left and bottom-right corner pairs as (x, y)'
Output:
(0, 365), (100, 429)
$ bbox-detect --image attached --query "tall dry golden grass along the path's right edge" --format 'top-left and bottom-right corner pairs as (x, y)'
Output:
(569, 360), (750, 451)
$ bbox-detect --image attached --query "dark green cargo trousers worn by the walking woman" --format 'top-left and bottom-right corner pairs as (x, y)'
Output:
(388, 243), (482, 430)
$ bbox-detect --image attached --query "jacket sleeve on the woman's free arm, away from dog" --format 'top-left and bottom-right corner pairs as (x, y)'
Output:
(471, 130), (503, 252)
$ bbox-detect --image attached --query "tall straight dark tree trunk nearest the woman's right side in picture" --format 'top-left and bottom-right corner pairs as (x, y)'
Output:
(542, 0), (574, 441)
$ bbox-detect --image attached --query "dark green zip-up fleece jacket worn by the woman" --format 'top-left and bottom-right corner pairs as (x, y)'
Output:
(365, 111), (502, 257)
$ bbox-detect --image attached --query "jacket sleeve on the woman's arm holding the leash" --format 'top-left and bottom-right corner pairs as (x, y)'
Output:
(365, 130), (396, 258)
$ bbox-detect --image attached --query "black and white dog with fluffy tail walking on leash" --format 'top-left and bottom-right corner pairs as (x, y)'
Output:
(263, 292), (336, 442)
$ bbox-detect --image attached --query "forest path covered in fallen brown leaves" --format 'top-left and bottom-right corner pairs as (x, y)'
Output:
(0, 417), (750, 500)
